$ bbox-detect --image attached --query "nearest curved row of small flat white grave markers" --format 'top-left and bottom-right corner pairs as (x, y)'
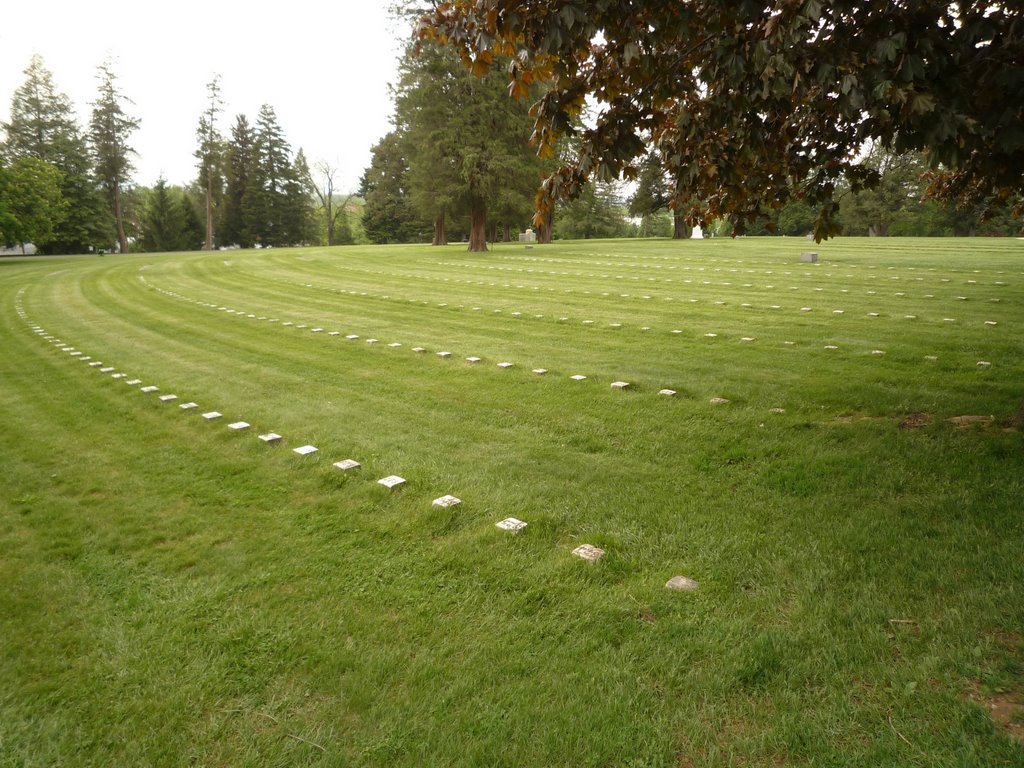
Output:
(14, 288), (698, 591)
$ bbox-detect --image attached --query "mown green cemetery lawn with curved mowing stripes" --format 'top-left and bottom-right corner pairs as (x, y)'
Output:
(0, 238), (1024, 768)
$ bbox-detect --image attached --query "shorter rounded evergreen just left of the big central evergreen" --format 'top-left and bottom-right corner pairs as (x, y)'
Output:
(359, 131), (423, 243)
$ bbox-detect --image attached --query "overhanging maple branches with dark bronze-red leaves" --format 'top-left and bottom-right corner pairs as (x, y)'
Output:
(420, 0), (1024, 239)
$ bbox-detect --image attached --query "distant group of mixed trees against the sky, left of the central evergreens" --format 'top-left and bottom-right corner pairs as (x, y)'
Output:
(0, 56), (352, 253)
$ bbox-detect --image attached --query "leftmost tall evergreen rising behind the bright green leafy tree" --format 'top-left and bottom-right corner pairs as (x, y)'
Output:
(0, 55), (106, 253)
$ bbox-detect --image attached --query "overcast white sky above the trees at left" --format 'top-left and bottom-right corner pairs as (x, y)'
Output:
(0, 0), (409, 191)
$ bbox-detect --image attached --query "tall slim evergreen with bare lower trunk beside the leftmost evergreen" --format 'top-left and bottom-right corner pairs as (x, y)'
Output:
(89, 61), (139, 253)
